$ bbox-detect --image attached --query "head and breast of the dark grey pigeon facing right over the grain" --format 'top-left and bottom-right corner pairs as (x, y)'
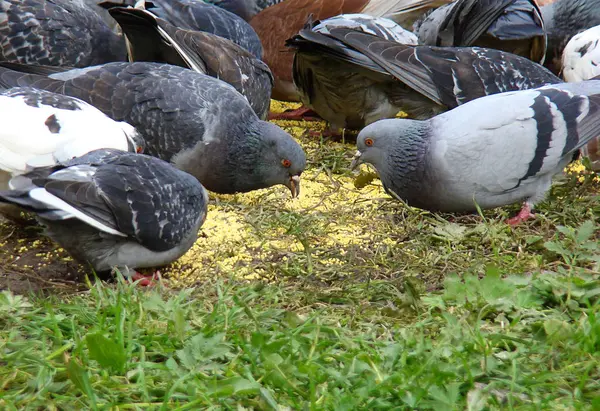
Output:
(180, 120), (306, 197)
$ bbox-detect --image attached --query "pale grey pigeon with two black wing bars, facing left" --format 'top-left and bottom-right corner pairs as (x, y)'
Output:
(351, 80), (600, 224)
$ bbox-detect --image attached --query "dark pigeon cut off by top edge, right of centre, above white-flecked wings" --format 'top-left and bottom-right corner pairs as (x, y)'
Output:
(414, 0), (546, 63)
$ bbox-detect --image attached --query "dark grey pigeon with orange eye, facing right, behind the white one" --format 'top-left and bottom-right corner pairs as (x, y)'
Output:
(0, 62), (306, 197)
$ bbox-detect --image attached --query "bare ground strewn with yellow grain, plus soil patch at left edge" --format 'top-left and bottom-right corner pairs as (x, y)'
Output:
(0, 102), (600, 292)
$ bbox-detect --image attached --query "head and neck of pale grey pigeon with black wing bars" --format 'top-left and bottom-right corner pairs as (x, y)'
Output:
(350, 119), (429, 185)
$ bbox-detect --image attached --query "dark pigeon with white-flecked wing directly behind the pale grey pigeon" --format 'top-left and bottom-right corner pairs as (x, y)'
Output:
(288, 23), (562, 131)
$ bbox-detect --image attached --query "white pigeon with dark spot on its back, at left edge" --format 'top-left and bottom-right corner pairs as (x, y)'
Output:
(0, 87), (143, 190)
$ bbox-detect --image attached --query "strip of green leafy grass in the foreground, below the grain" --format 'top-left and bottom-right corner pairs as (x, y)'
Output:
(0, 235), (600, 410)
